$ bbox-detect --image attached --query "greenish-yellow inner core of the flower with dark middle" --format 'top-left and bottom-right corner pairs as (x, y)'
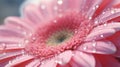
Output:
(46, 30), (73, 46)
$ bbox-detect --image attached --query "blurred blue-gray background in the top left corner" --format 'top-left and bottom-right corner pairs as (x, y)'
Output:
(0, 0), (24, 24)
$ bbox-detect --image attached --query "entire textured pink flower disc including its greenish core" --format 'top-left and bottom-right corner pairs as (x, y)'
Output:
(25, 12), (93, 59)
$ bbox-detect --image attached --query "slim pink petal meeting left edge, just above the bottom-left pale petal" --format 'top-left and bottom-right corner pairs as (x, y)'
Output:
(0, 51), (22, 60)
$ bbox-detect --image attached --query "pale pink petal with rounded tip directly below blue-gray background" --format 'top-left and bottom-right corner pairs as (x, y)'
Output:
(5, 17), (33, 32)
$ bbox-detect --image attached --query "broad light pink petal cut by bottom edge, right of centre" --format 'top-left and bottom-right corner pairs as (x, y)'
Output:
(72, 51), (95, 67)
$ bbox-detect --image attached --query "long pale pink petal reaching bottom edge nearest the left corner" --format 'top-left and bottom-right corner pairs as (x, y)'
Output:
(5, 55), (34, 67)
